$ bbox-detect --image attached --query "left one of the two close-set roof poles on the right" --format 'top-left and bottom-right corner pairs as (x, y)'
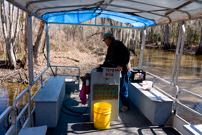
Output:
(171, 23), (182, 86)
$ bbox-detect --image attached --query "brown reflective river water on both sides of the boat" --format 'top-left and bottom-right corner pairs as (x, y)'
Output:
(0, 48), (202, 134)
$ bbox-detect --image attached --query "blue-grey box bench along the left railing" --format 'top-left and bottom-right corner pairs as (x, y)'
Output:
(33, 76), (65, 128)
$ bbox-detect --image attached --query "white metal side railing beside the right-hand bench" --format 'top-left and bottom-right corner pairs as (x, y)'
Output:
(146, 71), (202, 124)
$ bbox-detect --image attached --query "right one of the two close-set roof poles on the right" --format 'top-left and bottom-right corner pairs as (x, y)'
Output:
(175, 24), (186, 85)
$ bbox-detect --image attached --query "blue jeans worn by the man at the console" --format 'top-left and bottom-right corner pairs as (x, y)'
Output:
(120, 71), (131, 106)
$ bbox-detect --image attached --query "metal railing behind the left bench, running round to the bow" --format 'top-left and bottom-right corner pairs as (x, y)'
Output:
(0, 66), (80, 135)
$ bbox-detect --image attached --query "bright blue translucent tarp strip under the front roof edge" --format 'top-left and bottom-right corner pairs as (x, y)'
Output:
(43, 10), (155, 28)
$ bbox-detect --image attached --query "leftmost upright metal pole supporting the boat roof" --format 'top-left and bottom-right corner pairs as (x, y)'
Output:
(27, 14), (34, 85)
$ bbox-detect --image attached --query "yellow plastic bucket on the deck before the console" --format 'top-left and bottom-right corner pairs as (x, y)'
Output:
(93, 102), (112, 129)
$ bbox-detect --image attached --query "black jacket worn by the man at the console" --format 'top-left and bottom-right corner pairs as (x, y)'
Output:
(105, 40), (130, 72)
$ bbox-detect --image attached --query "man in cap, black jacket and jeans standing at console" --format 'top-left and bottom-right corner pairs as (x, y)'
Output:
(103, 32), (131, 112)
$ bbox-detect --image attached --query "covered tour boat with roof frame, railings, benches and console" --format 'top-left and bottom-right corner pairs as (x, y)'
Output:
(0, 0), (202, 135)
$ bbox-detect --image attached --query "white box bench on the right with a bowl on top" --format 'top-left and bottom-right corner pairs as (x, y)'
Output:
(128, 83), (173, 125)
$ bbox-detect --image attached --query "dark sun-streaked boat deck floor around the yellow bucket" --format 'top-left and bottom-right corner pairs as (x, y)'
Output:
(47, 93), (179, 135)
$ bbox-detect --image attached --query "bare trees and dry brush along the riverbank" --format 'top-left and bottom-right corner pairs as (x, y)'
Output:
(0, 2), (202, 83)
